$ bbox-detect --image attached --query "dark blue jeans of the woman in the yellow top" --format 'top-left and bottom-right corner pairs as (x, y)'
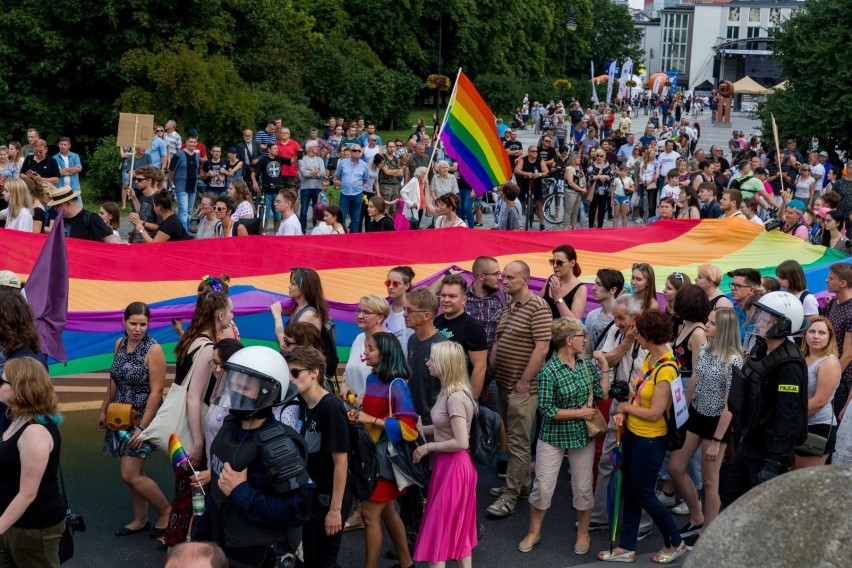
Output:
(618, 428), (682, 550)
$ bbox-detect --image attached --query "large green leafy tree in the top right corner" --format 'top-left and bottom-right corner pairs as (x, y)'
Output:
(759, 0), (852, 152)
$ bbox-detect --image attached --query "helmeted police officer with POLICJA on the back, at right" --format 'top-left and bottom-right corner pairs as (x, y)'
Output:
(720, 292), (809, 506)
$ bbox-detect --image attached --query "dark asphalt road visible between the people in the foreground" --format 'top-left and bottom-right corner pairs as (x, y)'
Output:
(58, 390), (685, 568)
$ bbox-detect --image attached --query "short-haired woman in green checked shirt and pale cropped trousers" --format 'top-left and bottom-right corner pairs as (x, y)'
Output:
(518, 317), (609, 554)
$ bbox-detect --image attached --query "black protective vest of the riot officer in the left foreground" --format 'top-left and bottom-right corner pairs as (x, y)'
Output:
(208, 416), (289, 548)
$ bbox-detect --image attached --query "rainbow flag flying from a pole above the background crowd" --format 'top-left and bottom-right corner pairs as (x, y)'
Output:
(441, 70), (512, 195)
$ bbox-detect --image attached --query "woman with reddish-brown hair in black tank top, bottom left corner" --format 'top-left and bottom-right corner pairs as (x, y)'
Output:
(0, 357), (65, 568)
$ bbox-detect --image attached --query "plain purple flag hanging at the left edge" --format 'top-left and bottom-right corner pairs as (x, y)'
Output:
(24, 215), (68, 363)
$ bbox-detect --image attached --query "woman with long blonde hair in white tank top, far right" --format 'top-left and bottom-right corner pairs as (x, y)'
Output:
(794, 316), (842, 469)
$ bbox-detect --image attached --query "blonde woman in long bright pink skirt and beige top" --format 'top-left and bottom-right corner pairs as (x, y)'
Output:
(414, 341), (477, 568)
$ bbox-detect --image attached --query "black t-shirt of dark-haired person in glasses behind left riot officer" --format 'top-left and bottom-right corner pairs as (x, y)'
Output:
(296, 394), (349, 495)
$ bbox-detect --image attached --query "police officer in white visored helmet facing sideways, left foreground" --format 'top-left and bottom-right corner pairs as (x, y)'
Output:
(205, 346), (313, 568)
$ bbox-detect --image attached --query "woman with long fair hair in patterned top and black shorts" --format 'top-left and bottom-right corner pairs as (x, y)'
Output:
(669, 308), (743, 538)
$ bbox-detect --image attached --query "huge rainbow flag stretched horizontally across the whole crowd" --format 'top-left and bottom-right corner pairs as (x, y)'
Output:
(0, 219), (847, 376)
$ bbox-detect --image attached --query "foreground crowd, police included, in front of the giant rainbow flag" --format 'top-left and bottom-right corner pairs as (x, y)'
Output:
(0, 244), (852, 567)
